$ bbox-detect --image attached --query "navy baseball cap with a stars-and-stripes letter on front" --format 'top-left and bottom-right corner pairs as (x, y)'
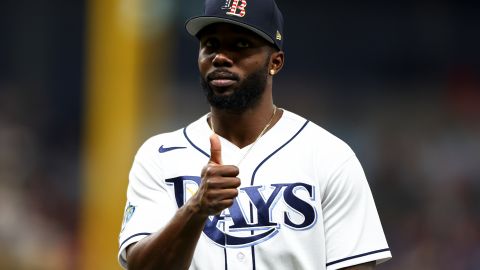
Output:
(185, 0), (283, 50)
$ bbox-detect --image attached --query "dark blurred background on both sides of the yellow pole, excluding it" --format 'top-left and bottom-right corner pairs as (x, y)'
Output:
(0, 0), (480, 270)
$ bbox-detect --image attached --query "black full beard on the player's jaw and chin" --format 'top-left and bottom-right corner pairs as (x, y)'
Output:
(201, 63), (268, 111)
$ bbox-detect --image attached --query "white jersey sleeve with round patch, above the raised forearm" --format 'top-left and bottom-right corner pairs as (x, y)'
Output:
(118, 138), (177, 269)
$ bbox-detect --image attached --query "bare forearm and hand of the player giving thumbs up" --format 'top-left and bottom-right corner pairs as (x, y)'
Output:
(127, 135), (240, 270)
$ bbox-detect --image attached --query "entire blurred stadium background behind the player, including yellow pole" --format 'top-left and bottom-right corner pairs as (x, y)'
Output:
(0, 0), (480, 270)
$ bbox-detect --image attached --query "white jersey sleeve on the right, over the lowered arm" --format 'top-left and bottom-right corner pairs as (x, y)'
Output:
(322, 153), (391, 270)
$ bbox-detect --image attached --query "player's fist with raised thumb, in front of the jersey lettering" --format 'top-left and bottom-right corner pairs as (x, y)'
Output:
(192, 134), (240, 217)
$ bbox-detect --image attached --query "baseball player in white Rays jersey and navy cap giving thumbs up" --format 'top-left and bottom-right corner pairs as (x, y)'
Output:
(119, 0), (391, 270)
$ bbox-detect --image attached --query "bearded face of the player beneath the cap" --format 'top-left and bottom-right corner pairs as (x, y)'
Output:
(198, 24), (272, 111)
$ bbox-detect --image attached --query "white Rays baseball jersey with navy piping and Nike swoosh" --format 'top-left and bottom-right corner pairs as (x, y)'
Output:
(119, 110), (391, 270)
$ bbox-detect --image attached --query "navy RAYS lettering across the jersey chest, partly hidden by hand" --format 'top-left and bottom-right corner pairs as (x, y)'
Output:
(165, 176), (317, 247)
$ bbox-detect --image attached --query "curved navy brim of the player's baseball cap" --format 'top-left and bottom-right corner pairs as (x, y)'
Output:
(185, 16), (275, 45)
